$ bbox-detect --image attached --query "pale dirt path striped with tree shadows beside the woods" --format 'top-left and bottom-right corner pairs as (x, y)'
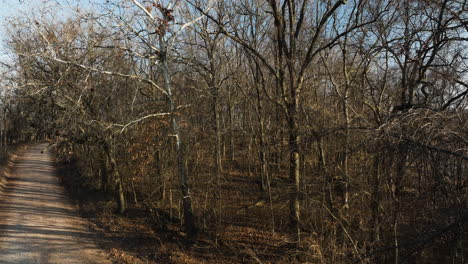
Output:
(0, 144), (110, 264)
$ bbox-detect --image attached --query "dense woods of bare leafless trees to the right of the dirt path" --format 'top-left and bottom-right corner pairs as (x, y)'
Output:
(0, 0), (468, 264)
